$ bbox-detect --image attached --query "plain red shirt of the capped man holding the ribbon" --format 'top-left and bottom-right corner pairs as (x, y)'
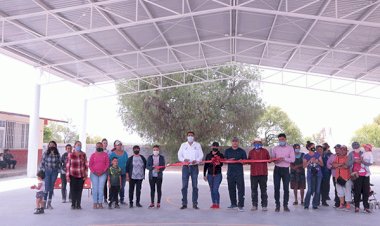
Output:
(248, 148), (270, 176)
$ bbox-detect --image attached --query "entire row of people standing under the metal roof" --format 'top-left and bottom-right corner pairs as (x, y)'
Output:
(32, 131), (373, 214)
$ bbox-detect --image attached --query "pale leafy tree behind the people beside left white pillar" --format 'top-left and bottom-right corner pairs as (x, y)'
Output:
(44, 119), (79, 143)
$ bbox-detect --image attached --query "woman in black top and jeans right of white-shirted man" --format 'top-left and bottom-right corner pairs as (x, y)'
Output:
(203, 142), (224, 209)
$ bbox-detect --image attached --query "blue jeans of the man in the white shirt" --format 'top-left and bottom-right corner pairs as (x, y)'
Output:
(181, 165), (199, 206)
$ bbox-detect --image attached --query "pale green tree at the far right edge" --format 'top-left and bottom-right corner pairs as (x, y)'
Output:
(352, 115), (380, 147)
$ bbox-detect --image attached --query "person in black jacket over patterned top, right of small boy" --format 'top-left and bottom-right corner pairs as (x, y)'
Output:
(126, 145), (146, 208)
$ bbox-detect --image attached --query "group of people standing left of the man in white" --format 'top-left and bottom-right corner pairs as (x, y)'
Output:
(31, 139), (165, 214)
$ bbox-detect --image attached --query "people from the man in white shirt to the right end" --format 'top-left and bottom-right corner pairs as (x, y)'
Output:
(178, 131), (373, 213)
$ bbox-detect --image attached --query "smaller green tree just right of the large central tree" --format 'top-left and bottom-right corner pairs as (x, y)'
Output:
(257, 106), (302, 146)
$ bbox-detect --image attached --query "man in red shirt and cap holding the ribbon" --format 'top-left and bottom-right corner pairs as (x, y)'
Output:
(248, 138), (270, 211)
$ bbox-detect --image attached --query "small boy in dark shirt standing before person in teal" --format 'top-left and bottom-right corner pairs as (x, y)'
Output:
(108, 157), (121, 209)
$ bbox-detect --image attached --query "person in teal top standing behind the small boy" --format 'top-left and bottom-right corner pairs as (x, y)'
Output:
(109, 140), (128, 205)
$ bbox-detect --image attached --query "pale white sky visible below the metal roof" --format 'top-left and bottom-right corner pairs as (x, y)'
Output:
(0, 55), (380, 144)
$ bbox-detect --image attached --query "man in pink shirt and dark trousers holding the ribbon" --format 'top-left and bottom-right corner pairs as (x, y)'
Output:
(272, 133), (295, 212)
